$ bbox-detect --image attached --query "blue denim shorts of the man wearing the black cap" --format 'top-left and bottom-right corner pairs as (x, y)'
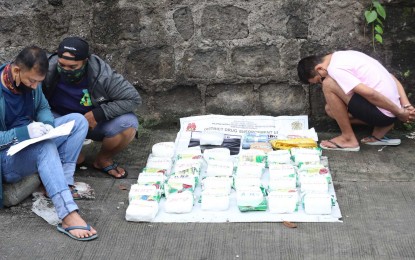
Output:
(86, 113), (138, 141)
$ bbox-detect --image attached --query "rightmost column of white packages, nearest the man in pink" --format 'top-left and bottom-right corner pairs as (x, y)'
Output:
(291, 148), (335, 215)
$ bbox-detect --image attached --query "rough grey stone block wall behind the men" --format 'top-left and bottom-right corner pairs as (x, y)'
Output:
(0, 0), (415, 126)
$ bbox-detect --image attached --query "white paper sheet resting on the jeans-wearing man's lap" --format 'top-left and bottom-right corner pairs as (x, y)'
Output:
(7, 120), (75, 156)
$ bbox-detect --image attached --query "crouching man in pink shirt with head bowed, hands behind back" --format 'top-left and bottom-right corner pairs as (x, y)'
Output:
(297, 50), (415, 151)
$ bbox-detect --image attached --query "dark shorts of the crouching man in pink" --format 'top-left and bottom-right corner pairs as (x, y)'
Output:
(348, 93), (397, 126)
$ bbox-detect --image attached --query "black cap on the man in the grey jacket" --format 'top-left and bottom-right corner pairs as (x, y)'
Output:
(58, 37), (89, 60)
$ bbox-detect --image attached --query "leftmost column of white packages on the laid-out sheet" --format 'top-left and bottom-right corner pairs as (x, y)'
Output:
(125, 142), (174, 221)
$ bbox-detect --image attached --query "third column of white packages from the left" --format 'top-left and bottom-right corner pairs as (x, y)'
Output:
(201, 148), (234, 211)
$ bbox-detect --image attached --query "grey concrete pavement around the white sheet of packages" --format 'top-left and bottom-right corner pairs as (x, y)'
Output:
(0, 129), (415, 260)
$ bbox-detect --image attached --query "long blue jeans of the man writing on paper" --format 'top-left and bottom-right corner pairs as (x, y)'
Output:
(0, 114), (88, 219)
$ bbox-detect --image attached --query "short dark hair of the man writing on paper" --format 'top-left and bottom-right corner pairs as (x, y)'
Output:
(14, 46), (49, 75)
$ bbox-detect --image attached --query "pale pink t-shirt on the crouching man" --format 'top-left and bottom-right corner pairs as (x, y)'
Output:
(327, 51), (401, 117)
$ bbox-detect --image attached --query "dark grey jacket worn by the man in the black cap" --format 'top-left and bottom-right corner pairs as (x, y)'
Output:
(43, 54), (141, 122)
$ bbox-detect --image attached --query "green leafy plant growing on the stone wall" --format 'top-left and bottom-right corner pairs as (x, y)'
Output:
(365, 1), (386, 50)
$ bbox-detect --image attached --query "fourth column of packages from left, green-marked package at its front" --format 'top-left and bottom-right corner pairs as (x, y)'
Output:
(234, 149), (267, 212)
